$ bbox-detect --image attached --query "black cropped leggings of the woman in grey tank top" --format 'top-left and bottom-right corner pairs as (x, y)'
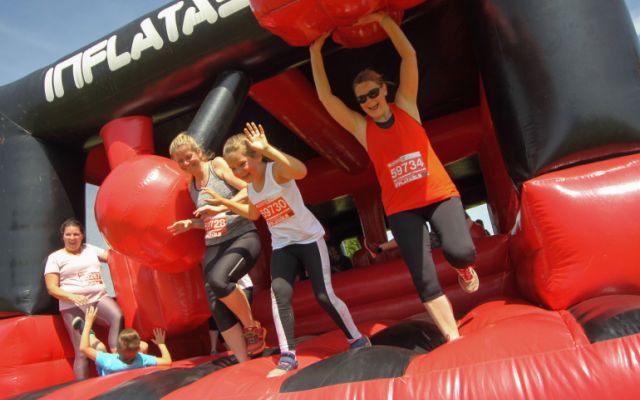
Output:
(203, 231), (260, 332)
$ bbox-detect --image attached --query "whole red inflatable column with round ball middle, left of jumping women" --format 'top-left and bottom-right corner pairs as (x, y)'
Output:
(95, 116), (210, 339)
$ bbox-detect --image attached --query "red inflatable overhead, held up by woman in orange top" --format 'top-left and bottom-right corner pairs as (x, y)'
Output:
(251, 0), (424, 47)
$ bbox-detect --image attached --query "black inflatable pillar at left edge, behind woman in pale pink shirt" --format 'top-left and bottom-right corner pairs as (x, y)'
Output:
(0, 118), (84, 316)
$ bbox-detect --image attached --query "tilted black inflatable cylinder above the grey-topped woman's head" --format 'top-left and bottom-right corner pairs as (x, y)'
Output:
(188, 71), (250, 152)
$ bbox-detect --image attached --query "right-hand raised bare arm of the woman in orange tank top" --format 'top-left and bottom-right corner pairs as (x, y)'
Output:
(367, 13), (420, 122)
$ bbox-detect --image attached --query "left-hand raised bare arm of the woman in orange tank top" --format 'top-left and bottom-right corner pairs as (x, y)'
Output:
(309, 33), (366, 147)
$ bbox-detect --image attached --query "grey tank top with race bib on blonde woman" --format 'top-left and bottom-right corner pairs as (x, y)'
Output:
(189, 161), (256, 246)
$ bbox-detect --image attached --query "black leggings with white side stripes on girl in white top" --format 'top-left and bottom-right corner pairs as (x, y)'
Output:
(271, 239), (361, 352)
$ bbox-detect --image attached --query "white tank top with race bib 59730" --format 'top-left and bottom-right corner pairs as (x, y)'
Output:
(248, 162), (324, 250)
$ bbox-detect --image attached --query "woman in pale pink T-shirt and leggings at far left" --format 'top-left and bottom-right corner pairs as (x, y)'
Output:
(44, 218), (123, 379)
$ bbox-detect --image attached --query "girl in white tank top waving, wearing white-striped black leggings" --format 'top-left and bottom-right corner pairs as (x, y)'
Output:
(202, 123), (371, 377)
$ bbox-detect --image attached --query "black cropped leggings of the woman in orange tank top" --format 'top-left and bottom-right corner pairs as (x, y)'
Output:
(388, 197), (476, 302)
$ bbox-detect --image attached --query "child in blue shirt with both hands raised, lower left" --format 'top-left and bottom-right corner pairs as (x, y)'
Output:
(80, 306), (171, 376)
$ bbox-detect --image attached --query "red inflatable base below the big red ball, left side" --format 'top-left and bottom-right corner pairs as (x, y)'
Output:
(109, 251), (211, 340)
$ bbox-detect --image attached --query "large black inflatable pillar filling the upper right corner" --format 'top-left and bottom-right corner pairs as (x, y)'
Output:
(467, 0), (640, 184)
